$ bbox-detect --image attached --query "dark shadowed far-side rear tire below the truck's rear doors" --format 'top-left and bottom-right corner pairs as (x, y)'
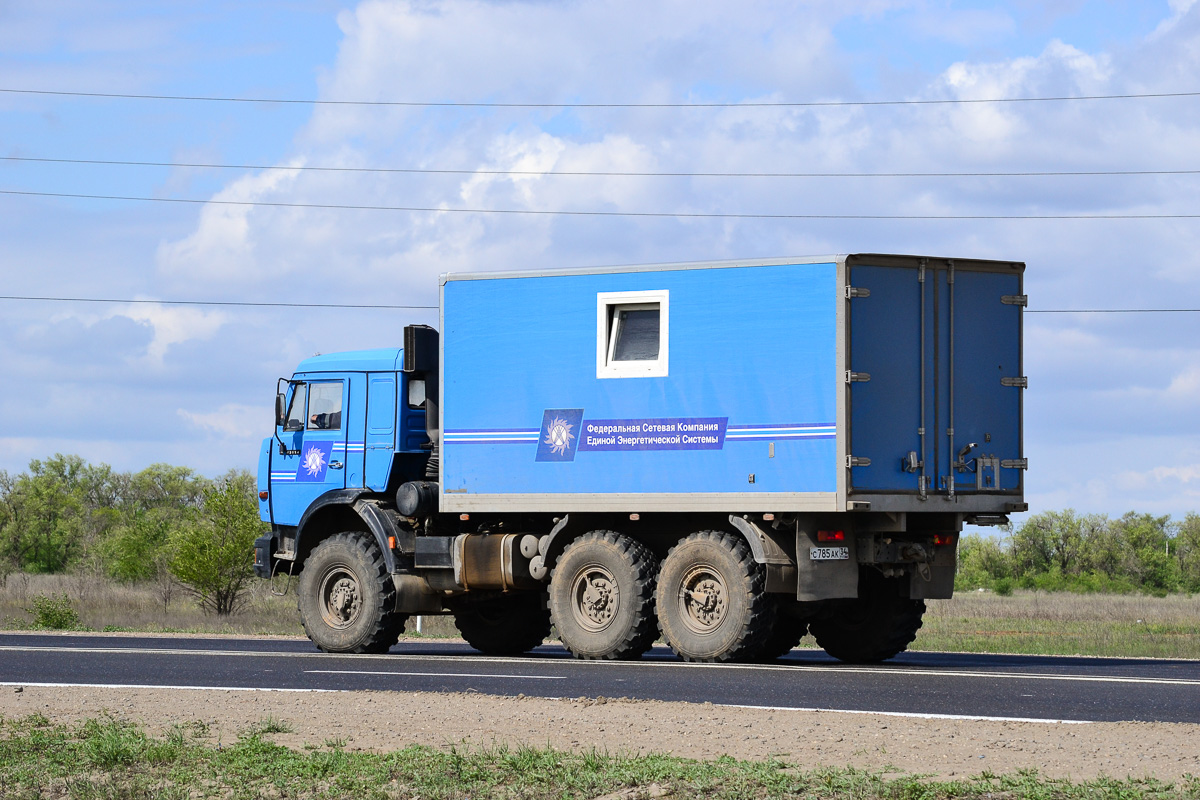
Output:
(809, 569), (925, 663)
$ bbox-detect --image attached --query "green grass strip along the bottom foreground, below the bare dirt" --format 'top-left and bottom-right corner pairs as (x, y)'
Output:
(0, 715), (1200, 800)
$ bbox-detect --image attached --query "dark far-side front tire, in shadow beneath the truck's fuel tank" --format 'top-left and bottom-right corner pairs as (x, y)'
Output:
(454, 593), (550, 656)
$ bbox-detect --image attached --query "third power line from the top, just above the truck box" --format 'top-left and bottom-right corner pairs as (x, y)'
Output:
(0, 190), (1200, 221)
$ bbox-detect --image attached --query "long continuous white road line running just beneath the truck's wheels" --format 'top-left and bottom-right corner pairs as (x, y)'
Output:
(0, 645), (1200, 686)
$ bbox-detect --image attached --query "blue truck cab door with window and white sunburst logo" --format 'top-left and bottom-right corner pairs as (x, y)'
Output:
(270, 374), (350, 525)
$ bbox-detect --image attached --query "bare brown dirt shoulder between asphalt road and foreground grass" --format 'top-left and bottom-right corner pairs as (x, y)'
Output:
(0, 686), (1200, 781)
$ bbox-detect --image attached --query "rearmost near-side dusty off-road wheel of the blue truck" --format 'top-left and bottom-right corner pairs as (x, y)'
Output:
(656, 530), (775, 661)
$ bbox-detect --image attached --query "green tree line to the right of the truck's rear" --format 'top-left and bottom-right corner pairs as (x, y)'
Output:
(954, 509), (1200, 595)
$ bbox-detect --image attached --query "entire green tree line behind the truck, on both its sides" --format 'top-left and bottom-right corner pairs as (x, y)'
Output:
(0, 455), (1200, 604)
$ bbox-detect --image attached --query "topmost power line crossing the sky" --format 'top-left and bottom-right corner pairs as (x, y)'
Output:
(7, 88), (1200, 108)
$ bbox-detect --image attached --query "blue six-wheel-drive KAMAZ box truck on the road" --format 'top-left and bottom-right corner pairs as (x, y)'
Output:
(254, 254), (1027, 662)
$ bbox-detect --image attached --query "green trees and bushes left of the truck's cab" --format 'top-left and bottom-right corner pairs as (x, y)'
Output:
(0, 455), (265, 614)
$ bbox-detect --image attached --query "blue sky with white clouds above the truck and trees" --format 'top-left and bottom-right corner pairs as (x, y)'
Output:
(0, 0), (1200, 517)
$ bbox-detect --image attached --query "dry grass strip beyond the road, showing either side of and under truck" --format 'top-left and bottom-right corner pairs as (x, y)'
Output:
(0, 575), (1200, 658)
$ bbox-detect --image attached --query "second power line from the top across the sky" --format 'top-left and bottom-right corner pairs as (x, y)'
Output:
(9, 156), (1200, 178)
